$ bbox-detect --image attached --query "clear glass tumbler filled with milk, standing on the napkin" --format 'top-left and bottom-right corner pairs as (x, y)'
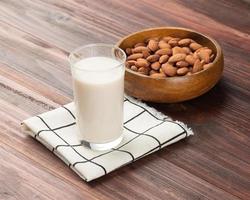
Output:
(69, 44), (126, 150)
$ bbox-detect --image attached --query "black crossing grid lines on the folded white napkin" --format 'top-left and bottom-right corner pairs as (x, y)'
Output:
(29, 98), (188, 181)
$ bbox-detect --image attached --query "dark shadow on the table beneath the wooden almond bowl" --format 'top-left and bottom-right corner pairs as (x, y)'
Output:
(148, 79), (229, 124)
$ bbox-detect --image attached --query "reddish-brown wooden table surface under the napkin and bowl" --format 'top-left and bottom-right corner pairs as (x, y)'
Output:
(0, 0), (250, 200)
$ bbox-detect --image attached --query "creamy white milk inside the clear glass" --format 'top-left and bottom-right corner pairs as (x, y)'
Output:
(73, 57), (124, 143)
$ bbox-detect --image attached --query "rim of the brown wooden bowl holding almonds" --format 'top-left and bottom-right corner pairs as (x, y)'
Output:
(116, 26), (222, 80)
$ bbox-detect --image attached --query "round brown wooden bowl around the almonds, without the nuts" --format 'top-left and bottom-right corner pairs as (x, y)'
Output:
(117, 27), (224, 103)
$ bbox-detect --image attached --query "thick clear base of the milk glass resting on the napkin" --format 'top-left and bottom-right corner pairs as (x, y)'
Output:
(81, 136), (123, 151)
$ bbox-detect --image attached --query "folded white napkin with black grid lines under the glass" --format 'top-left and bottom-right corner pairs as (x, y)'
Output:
(22, 97), (193, 181)
